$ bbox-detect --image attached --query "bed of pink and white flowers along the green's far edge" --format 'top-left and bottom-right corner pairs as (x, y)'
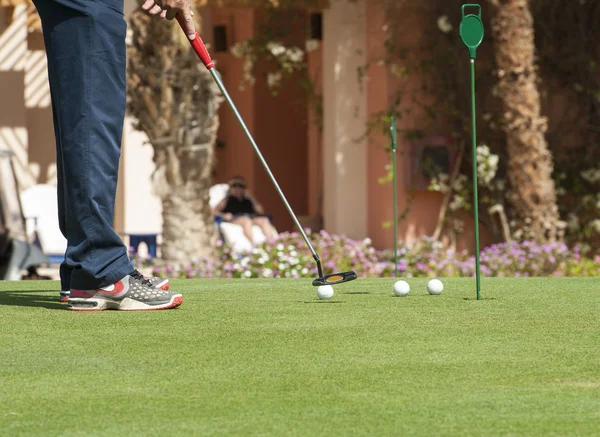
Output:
(144, 231), (600, 278)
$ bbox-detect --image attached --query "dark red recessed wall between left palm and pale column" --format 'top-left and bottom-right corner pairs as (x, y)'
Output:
(211, 8), (309, 231)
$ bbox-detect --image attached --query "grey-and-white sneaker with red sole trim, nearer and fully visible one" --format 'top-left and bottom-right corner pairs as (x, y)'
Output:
(67, 274), (183, 311)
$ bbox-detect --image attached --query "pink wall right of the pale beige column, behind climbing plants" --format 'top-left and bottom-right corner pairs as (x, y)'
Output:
(366, 0), (490, 250)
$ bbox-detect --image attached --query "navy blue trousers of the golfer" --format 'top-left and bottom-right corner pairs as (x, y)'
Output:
(34, 0), (134, 290)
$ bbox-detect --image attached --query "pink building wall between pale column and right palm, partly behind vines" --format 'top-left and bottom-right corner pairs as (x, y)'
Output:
(366, 0), (490, 250)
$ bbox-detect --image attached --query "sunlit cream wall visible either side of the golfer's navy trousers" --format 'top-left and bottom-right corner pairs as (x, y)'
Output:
(0, 0), (162, 242)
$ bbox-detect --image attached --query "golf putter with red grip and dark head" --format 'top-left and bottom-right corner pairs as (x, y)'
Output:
(176, 14), (358, 287)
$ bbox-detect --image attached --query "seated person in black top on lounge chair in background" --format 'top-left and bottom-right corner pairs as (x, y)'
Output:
(214, 176), (277, 243)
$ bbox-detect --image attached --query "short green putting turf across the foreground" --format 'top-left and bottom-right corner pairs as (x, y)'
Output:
(0, 278), (600, 436)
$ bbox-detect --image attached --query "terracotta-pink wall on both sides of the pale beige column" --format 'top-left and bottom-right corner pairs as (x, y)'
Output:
(205, 2), (480, 248)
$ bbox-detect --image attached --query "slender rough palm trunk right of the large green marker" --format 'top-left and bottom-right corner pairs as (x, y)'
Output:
(489, 0), (564, 241)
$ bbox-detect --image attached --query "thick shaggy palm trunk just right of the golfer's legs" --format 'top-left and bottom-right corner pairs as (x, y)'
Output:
(128, 5), (222, 262)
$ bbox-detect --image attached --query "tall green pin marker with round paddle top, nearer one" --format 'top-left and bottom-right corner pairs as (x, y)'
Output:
(459, 4), (483, 300)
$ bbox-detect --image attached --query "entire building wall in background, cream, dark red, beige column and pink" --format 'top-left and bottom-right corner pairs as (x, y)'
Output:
(0, 0), (506, 255)
